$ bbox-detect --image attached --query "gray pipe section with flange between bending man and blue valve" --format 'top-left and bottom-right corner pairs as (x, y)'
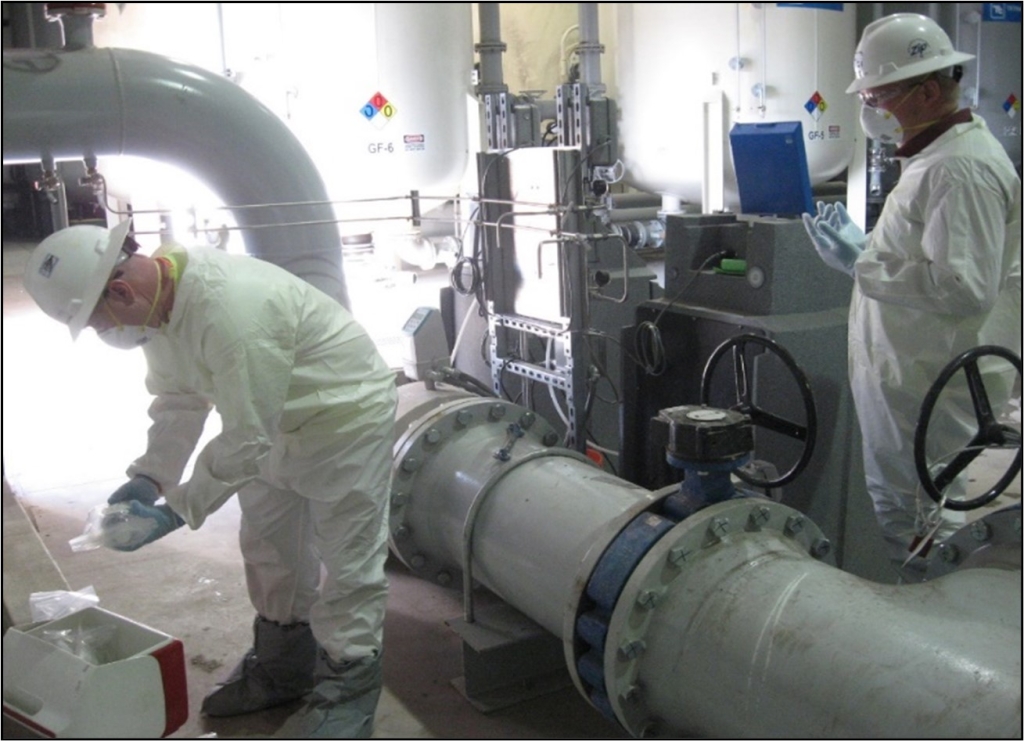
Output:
(391, 384), (652, 636)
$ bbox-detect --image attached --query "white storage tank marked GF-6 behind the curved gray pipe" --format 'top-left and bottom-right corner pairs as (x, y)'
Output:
(95, 2), (473, 202)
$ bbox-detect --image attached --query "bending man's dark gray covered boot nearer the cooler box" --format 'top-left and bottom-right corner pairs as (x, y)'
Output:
(203, 616), (316, 717)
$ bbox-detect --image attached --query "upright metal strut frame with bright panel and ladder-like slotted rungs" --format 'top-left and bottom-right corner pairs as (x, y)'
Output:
(478, 148), (589, 451)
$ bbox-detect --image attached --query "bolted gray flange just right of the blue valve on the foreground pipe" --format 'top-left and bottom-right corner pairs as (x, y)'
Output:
(604, 497), (834, 738)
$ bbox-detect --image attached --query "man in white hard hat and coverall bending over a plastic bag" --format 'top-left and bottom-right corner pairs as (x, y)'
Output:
(25, 222), (396, 738)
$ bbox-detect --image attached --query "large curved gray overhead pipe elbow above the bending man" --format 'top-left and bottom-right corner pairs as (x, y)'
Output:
(3, 48), (349, 307)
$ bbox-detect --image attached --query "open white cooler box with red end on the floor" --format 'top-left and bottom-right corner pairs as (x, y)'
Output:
(3, 607), (188, 739)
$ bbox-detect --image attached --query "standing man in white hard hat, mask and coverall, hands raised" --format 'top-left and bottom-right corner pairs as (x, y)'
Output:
(804, 13), (1021, 564)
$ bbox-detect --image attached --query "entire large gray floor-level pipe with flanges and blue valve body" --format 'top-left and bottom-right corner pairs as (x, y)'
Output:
(391, 384), (1021, 738)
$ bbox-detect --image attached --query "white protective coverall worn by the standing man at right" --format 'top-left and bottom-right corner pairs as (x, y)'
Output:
(849, 112), (1021, 557)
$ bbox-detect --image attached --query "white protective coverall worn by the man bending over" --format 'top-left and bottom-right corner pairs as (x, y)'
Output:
(128, 248), (396, 661)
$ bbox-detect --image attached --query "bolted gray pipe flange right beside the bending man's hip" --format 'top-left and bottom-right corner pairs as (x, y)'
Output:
(388, 397), (554, 586)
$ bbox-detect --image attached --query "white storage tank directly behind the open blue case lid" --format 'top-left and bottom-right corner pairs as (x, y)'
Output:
(615, 3), (858, 211)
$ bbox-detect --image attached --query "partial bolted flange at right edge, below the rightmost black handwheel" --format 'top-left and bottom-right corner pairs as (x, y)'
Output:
(925, 505), (1022, 581)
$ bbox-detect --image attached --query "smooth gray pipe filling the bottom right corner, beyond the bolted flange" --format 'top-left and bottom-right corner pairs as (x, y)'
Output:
(634, 506), (1021, 738)
